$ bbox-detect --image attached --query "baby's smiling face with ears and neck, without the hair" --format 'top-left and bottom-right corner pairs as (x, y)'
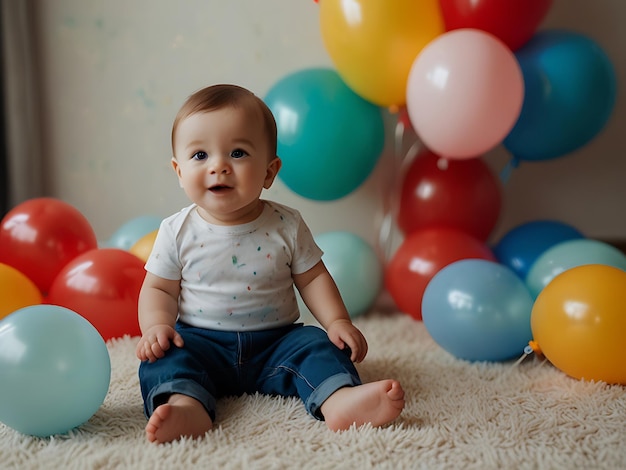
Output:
(172, 107), (280, 225)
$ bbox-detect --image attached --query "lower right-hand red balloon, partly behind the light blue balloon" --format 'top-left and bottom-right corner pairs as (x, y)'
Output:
(385, 228), (495, 321)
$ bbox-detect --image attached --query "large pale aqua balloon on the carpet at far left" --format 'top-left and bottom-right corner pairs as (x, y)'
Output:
(0, 305), (111, 437)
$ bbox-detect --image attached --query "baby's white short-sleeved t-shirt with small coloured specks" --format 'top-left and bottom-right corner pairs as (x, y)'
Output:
(146, 201), (322, 331)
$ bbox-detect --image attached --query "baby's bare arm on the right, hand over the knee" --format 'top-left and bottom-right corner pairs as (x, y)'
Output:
(293, 261), (367, 362)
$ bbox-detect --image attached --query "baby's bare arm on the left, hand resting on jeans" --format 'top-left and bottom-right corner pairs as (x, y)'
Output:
(136, 272), (183, 362)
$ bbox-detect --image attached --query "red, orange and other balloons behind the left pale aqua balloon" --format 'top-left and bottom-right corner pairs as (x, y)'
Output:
(0, 198), (160, 341)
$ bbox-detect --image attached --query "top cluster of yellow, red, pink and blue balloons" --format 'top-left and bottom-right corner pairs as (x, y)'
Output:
(320, 0), (616, 161)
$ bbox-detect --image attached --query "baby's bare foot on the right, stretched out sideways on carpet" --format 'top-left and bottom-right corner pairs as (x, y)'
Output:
(321, 379), (404, 431)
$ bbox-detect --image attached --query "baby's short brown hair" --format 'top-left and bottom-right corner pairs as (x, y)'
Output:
(172, 84), (278, 155)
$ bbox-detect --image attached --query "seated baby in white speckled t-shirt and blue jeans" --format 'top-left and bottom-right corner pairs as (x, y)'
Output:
(137, 85), (404, 443)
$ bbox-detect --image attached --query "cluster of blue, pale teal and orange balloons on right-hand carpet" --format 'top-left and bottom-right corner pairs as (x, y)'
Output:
(416, 220), (626, 384)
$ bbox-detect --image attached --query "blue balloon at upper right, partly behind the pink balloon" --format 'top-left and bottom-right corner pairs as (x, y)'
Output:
(504, 31), (617, 160)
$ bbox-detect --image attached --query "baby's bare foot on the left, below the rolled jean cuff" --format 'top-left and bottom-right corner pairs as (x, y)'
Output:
(146, 395), (213, 444)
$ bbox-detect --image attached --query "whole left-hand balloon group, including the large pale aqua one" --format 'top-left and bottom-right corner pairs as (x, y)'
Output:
(0, 198), (160, 436)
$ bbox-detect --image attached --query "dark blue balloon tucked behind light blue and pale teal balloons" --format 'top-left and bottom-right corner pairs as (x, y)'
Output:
(493, 220), (585, 280)
